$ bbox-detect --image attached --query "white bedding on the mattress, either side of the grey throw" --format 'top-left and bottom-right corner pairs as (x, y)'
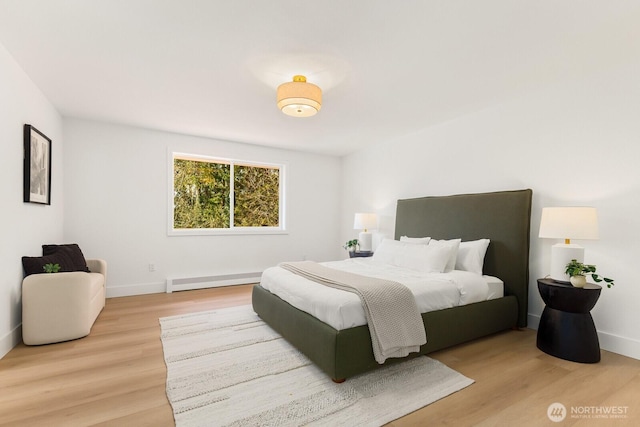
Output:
(260, 258), (504, 330)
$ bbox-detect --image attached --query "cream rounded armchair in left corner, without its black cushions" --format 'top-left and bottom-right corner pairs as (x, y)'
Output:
(22, 259), (107, 345)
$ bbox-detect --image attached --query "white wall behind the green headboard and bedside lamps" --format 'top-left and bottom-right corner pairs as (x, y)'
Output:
(341, 66), (640, 358)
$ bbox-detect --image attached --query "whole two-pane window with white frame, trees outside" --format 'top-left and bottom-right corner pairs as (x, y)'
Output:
(169, 153), (285, 235)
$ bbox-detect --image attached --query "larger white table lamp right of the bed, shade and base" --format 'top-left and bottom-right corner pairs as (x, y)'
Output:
(538, 206), (598, 282)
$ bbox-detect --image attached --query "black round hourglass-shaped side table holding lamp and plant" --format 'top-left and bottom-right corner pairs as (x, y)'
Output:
(537, 279), (602, 363)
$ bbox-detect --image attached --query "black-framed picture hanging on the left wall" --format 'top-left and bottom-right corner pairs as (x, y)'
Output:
(23, 124), (51, 205)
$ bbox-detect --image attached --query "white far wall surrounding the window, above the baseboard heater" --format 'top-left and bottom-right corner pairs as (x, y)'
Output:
(64, 119), (341, 296)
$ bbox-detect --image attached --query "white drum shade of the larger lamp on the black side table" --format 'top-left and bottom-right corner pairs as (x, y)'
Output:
(538, 206), (598, 243)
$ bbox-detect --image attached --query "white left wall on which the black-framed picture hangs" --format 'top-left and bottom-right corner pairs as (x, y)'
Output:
(0, 45), (63, 357)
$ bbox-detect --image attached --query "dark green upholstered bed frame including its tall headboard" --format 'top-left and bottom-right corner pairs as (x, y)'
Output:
(252, 189), (532, 382)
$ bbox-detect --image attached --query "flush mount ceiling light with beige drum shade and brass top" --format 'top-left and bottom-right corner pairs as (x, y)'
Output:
(278, 76), (322, 117)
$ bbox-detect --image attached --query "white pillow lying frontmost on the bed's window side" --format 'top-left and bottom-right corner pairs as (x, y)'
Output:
(372, 239), (457, 273)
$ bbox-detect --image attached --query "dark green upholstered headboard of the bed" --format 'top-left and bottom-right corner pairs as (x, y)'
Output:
(395, 189), (532, 327)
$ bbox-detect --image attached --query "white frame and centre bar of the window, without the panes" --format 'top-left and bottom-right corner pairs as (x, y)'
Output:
(167, 151), (287, 236)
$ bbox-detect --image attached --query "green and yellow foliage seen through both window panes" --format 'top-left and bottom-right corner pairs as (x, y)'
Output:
(173, 158), (280, 229)
